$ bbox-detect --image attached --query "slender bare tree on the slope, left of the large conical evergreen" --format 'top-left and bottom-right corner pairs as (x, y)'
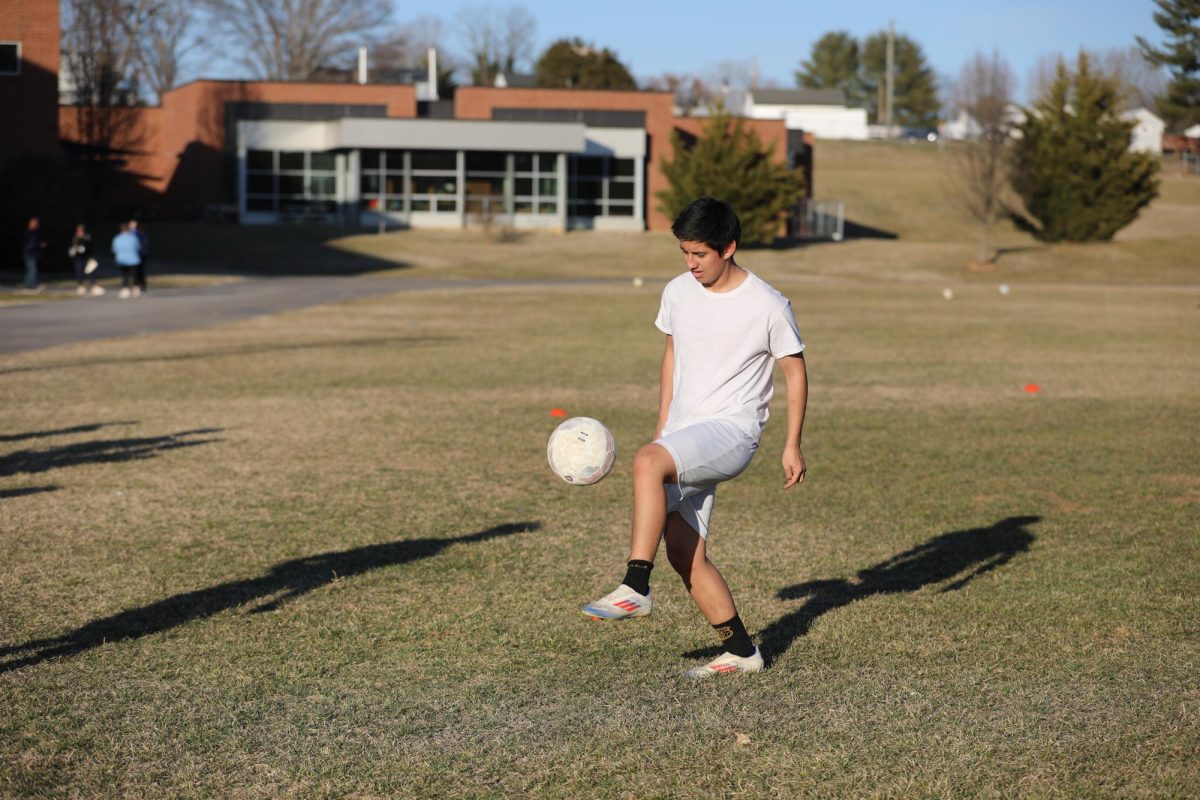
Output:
(953, 52), (1013, 264)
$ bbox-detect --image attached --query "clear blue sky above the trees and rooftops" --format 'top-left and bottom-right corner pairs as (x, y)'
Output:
(396, 0), (1162, 96)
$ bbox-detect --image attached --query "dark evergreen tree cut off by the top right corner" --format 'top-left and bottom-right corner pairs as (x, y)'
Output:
(1138, 0), (1200, 131)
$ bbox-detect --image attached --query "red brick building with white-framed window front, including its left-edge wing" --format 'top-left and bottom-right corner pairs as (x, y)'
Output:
(7, 0), (809, 230)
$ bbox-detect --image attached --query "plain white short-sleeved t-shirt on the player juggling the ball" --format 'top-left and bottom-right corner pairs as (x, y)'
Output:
(654, 270), (804, 441)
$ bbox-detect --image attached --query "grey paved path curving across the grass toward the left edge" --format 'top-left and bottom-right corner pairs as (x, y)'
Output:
(0, 276), (608, 355)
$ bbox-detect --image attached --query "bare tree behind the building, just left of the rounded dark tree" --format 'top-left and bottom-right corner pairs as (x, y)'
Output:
(457, 6), (538, 86)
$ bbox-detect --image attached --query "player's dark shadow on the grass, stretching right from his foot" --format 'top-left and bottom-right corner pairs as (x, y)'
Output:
(686, 516), (1042, 664)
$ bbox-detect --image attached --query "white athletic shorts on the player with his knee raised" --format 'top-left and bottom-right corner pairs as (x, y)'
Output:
(654, 420), (758, 539)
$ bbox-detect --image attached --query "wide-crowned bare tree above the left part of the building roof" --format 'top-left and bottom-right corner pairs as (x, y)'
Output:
(204, 0), (392, 80)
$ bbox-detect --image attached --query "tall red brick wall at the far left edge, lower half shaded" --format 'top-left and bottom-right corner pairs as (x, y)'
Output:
(0, 0), (59, 163)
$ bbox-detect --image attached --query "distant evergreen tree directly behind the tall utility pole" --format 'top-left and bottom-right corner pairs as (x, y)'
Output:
(859, 31), (942, 127)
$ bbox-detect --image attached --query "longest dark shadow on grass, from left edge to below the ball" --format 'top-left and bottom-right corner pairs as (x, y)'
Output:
(0, 522), (541, 673)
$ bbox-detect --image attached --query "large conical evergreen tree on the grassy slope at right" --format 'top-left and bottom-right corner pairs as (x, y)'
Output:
(1013, 53), (1158, 242)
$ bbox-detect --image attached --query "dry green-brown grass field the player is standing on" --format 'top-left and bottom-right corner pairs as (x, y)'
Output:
(0, 139), (1200, 799)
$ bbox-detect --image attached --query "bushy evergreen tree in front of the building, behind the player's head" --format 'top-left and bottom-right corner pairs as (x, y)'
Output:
(658, 113), (804, 243)
